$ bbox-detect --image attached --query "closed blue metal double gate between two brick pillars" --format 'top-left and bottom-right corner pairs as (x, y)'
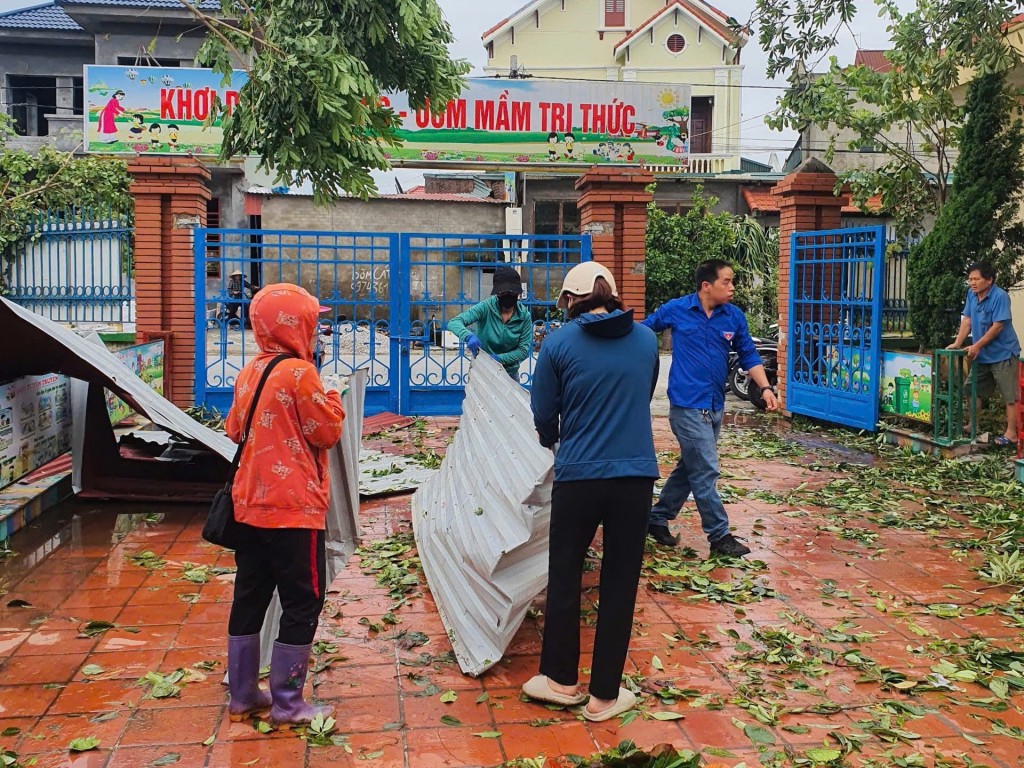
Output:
(195, 229), (591, 416)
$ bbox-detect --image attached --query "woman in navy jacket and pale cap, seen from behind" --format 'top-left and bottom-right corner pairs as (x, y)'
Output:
(523, 262), (658, 721)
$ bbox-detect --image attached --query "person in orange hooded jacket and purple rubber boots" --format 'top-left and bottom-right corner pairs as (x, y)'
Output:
(226, 283), (345, 726)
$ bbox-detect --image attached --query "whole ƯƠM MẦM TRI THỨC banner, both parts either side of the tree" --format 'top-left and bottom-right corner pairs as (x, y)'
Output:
(84, 66), (690, 170)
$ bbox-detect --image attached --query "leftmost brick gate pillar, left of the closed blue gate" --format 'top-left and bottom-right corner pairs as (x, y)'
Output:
(128, 156), (210, 408)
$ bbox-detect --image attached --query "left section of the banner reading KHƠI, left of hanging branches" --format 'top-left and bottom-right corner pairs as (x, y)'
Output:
(83, 65), (248, 155)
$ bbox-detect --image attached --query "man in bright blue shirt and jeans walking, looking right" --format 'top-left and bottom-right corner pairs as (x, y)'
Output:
(643, 259), (778, 557)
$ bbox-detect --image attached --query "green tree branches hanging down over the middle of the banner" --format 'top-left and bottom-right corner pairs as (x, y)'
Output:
(180, 0), (470, 202)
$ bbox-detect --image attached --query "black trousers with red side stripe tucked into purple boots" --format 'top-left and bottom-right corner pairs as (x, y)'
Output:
(227, 525), (328, 645)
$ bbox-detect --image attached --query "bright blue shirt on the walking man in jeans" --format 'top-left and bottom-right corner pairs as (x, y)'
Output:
(643, 293), (762, 411)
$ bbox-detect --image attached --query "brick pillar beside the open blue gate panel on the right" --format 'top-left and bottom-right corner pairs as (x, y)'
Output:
(772, 158), (845, 410)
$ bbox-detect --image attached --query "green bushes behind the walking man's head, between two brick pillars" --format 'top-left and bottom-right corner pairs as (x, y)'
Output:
(645, 185), (778, 333)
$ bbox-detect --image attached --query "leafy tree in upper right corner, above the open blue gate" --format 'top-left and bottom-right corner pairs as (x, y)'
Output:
(750, 0), (1021, 234)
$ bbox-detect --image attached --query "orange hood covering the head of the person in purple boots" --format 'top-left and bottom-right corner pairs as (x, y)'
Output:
(249, 283), (319, 361)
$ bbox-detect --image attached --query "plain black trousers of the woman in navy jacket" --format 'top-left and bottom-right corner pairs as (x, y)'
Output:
(541, 477), (654, 699)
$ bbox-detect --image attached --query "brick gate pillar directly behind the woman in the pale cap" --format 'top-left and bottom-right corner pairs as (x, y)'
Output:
(575, 166), (654, 319)
